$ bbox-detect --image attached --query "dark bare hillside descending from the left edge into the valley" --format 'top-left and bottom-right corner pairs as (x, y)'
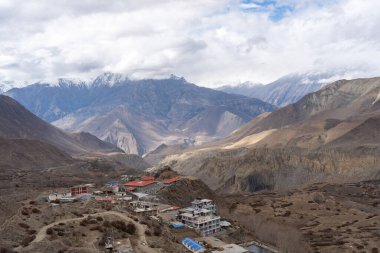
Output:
(0, 95), (120, 155)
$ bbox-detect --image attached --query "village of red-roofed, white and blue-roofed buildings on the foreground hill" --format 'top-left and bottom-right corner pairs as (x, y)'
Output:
(47, 169), (276, 253)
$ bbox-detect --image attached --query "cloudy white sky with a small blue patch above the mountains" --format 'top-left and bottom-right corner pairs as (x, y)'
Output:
(0, 0), (380, 87)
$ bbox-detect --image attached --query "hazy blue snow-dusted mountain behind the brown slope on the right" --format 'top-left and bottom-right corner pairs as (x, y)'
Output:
(219, 73), (335, 107)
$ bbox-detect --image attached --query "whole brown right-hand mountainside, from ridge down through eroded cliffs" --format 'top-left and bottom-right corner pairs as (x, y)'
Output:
(155, 78), (380, 192)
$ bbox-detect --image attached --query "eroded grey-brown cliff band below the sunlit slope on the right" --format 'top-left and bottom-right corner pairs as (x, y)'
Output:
(166, 148), (380, 192)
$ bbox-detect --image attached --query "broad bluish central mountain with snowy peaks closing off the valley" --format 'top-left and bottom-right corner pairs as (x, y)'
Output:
(6, 73), (275, 155)
